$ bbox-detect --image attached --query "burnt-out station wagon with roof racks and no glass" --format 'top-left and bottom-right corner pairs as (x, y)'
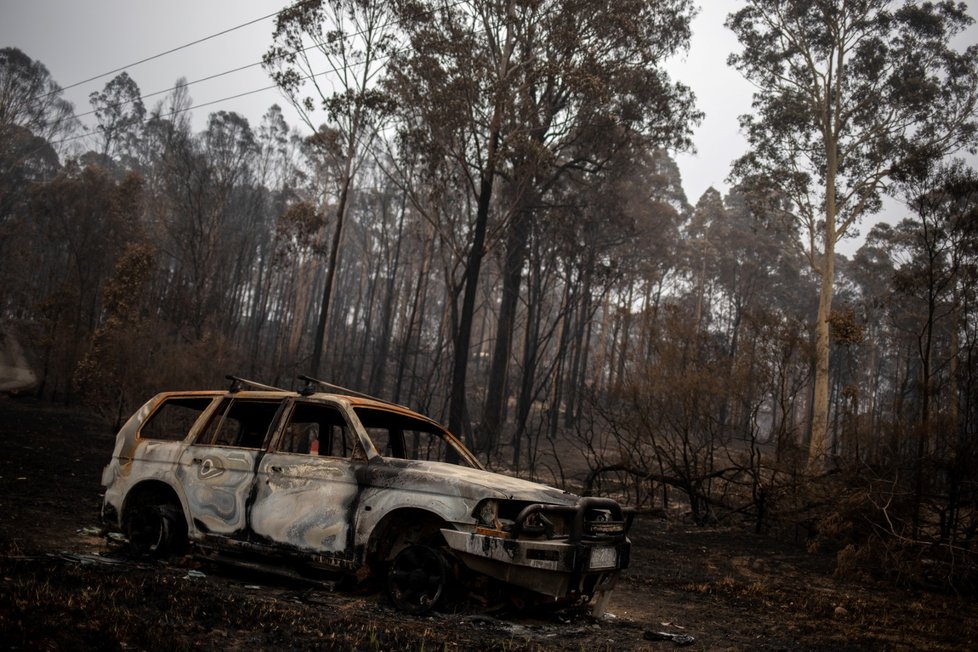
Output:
(102, 376), (629, 613)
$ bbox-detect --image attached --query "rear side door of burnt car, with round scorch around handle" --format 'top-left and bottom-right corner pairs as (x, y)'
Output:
(177, 398), (281, 537)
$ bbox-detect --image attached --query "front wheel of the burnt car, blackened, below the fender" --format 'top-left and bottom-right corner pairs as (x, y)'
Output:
(387, 544), (452, 614)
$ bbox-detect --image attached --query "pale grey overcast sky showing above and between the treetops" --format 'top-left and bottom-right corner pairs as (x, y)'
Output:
(0, 0), (978, 236)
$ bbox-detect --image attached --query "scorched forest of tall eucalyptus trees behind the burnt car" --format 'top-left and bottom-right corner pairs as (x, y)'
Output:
(0, 0), (978, 590)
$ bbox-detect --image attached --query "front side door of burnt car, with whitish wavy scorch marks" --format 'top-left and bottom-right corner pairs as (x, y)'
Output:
(250, 400), (363, 565)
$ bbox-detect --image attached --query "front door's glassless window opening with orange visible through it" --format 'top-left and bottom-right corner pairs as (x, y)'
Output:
(279, 402), (354, 458)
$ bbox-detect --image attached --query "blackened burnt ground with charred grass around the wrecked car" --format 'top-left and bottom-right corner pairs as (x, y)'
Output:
(0, 398), (978, 651)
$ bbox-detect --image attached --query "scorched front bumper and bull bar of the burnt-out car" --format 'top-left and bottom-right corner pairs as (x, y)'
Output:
(441, 498), (631, 599)
